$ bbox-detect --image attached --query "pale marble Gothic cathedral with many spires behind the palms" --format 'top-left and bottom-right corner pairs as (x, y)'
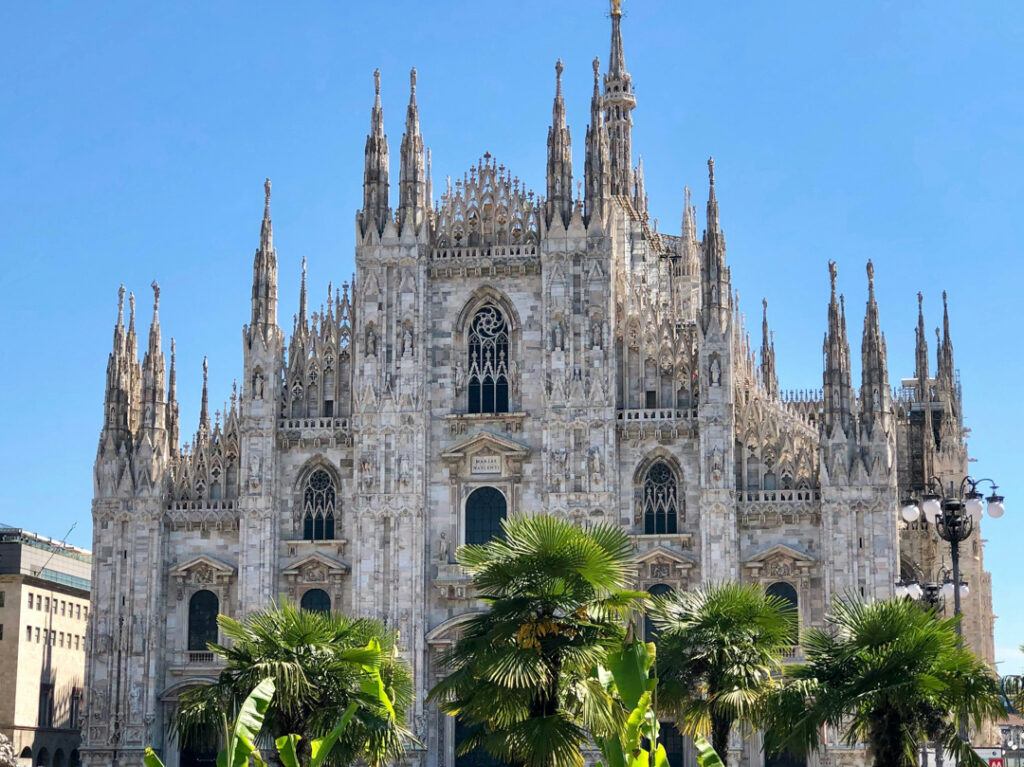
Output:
(82, 2), (993, 767)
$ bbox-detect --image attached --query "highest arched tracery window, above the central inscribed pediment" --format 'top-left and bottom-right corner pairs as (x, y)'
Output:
(467, 303), (509, 413)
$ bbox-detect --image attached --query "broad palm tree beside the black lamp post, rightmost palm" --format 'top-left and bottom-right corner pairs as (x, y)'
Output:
(765, 598), (1002, 767)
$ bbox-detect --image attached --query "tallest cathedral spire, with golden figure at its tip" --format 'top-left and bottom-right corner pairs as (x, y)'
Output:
(604, 0), (637, 197)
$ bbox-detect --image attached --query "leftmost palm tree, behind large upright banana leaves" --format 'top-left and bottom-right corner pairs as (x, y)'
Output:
(173, 602), (413, 766)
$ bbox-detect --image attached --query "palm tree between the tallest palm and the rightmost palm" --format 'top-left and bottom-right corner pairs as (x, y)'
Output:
(651, 581), (798, 754)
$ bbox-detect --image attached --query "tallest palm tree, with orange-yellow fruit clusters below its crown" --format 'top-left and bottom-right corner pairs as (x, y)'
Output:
(430, 515), (643, 767)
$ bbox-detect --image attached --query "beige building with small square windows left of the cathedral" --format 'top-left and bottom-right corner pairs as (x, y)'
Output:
(0, 527), (92, 767)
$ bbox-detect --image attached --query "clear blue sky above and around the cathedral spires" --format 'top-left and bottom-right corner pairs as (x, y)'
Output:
(0, 0), (1024, 672)
